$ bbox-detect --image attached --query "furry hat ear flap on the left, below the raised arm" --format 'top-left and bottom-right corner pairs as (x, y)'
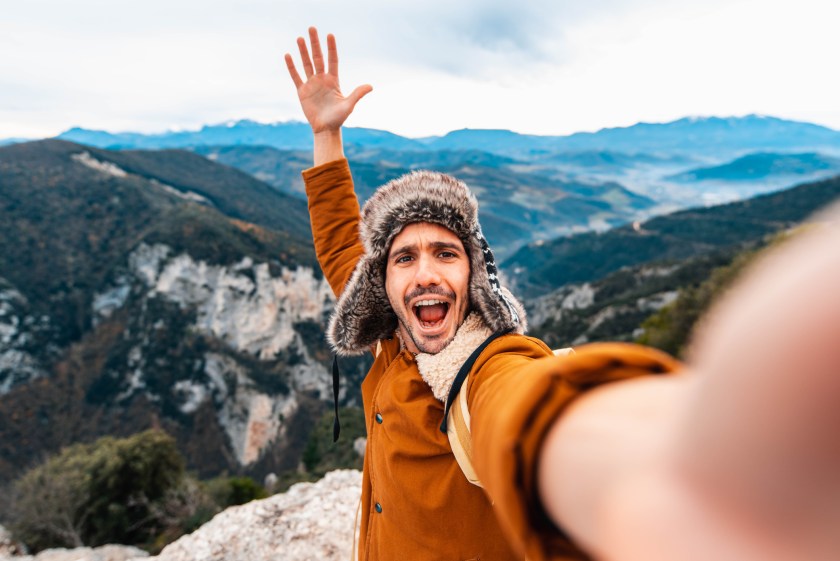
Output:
(327, 256), (397, 356)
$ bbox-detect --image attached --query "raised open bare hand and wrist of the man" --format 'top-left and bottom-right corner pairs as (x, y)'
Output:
(285, 27), (373, 166)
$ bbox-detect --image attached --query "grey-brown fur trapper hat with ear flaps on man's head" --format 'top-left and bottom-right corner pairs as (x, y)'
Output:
(327, 171), (526, 356)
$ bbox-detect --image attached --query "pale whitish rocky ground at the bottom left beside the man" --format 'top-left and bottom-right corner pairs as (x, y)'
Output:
(0, 470), (362, 561)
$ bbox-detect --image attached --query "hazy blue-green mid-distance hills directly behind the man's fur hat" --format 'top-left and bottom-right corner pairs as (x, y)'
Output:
(190, 146), (655, 257)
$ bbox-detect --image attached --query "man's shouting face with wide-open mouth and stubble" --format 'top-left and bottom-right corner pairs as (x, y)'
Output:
(385, 222), (470, 354)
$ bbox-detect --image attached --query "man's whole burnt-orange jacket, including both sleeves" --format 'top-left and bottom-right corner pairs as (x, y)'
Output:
(303, 160), (677, 561)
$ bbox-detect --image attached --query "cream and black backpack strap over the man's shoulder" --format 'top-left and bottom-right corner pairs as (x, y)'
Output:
(440, 331), (575, 487)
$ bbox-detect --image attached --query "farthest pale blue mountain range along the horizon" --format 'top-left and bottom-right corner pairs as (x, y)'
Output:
(50, 115), (840, 158)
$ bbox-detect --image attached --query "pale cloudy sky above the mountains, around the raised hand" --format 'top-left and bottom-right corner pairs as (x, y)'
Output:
(0, 0), (840, 139)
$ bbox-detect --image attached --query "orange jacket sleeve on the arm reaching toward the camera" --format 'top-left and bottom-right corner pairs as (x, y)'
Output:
(468, 336), (680, 561)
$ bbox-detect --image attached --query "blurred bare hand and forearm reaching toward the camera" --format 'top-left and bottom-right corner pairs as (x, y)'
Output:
(539, 208), (840, 561)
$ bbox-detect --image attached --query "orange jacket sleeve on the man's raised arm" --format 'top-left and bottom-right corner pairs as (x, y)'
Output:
(302, 159), (363, 296)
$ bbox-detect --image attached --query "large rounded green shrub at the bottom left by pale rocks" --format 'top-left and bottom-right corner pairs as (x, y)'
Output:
(11, 430), (188, 551)
